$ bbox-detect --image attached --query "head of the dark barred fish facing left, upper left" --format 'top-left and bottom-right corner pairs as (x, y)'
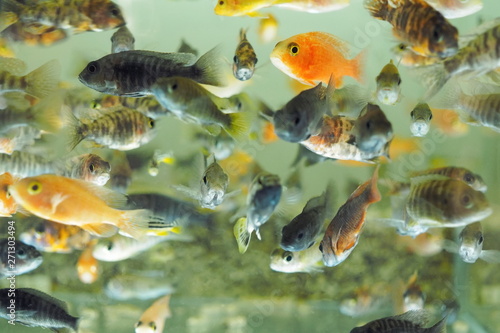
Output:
(78, 57), (117, 94)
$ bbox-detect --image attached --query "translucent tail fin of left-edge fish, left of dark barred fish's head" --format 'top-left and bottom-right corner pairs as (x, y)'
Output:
(25, 59), (61, 97)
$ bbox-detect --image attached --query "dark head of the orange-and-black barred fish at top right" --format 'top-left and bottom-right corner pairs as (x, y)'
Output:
(422, 18), (458, 58)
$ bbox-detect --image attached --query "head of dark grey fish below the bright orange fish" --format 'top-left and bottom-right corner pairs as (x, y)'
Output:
(273, 108), (311, 143)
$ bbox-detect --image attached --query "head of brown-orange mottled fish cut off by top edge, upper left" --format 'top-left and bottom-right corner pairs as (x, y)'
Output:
(89, 0), (125, 31)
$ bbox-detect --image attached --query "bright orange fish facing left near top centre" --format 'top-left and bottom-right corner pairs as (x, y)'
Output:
(271, 31), (364, 88)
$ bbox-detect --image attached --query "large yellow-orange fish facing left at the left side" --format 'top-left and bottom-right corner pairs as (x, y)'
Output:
(8, 175), (170, 238)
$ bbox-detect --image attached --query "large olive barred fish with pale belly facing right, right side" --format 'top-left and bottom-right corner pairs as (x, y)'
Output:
(406, 176), (493, 228)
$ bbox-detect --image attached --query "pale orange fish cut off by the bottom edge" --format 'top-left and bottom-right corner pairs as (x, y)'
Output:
(135, 295), (172, 333)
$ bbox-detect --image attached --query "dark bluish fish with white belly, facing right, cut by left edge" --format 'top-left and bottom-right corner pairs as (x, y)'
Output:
(0, 238), (43, 277)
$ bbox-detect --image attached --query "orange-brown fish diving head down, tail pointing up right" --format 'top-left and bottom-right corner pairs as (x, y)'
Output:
(319, 164), (382, 267)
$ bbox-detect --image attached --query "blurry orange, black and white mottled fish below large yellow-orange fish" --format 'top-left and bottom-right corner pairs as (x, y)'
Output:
(20, 220), (93, 253)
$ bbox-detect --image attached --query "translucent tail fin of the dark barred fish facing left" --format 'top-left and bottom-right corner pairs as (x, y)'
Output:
(193, 47), (225, 87)
